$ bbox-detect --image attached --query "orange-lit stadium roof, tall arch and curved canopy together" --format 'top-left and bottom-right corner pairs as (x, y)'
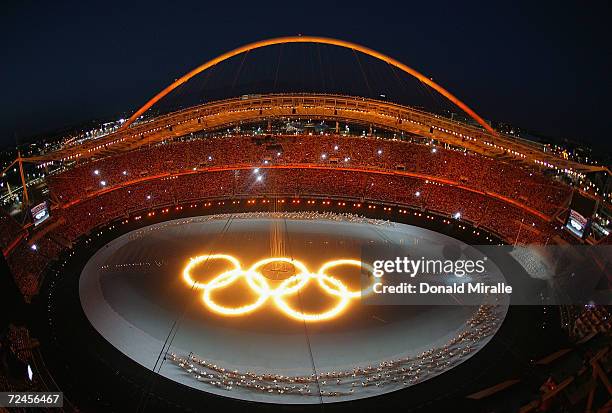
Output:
(23, 36), (607, 173)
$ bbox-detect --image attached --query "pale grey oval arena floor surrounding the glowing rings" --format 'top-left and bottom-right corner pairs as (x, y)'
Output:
(79, 213), (508, 404)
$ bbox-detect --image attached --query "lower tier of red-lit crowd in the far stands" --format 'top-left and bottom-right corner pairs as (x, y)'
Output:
(47, 168), (550, 243)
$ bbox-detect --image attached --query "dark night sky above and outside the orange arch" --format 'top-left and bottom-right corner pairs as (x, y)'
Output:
(0, 0), (612, 150)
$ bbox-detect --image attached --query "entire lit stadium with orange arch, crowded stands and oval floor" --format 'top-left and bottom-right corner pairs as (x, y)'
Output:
(0, 36), (612, 412)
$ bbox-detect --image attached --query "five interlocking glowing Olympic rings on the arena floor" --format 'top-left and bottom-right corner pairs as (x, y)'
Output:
(183, 254), (374, 322)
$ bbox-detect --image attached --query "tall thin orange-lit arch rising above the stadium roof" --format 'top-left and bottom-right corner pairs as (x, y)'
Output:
(122, 36), (495, 134)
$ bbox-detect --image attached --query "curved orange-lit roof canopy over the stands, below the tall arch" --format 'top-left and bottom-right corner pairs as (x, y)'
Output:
(24, 93), (604, 173)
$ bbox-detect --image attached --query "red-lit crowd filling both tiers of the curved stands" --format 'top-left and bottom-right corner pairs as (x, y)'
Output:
(5, 135), (569, 296)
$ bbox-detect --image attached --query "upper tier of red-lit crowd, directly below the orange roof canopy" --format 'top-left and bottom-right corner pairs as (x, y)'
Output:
(49, 135), (570, 215)
